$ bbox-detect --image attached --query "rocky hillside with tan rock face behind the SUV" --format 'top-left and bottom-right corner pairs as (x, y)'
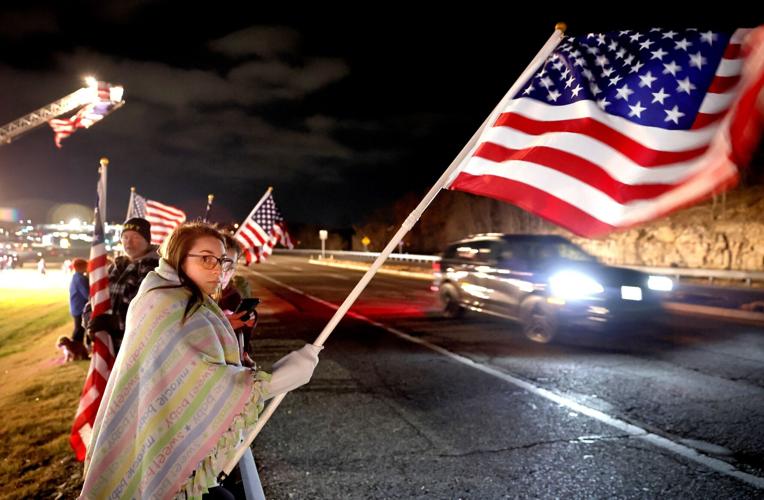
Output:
(353, 184), (764, 271)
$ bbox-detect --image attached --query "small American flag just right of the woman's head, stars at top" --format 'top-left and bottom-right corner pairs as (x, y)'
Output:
(234, 192), (293, 264)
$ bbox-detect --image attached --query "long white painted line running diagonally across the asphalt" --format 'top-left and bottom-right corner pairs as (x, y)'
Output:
(253, 271), (764, 489)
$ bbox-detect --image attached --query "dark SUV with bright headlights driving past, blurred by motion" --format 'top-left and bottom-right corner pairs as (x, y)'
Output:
(432, 234), (673, 342)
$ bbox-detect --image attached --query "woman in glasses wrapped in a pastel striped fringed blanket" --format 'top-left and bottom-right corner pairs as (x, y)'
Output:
(81, 222), (321, 499)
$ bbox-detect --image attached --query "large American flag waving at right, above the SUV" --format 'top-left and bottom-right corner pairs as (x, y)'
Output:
(449, 28), (764, 237)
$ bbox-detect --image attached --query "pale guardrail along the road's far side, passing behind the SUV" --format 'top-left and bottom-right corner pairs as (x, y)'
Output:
(274, 249), (764, 286)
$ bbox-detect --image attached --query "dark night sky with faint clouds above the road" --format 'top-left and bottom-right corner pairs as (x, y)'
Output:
(0, 1), (764, 227)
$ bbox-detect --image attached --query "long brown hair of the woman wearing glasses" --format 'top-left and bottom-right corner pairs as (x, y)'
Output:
(159, 222), (225, 322)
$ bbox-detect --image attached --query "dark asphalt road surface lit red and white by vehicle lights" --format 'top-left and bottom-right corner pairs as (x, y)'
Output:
(240, 256), (764, 499)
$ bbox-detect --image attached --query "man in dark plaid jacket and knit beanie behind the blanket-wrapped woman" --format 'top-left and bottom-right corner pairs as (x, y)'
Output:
(85, 217), (159, 354)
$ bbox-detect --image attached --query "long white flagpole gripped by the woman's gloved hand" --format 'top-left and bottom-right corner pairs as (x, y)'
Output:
(223, 23), (566, 475)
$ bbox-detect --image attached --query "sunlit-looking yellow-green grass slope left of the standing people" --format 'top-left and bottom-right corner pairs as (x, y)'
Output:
(0, 276), (88, 498)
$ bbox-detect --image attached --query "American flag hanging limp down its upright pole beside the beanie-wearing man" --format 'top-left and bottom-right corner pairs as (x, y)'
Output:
(69, 167), (115, 461)
